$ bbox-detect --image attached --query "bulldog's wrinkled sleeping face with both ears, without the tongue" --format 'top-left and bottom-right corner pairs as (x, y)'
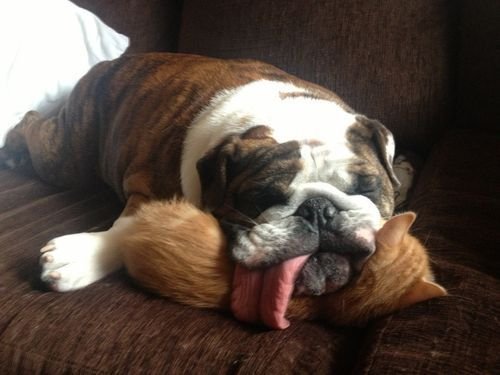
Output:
(197, 121), (397, 294)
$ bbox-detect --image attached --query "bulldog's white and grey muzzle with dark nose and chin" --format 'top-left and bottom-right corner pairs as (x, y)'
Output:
(231, 183), (380, 295)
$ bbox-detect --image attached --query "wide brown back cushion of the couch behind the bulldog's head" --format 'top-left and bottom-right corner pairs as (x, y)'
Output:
(179, 0), (456, 153)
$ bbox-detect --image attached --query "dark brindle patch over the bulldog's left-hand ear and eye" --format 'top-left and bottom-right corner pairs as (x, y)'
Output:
(197, 126), (302, 217)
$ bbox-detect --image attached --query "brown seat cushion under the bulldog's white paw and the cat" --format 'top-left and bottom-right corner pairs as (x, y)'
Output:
(0, 170), (362, 374)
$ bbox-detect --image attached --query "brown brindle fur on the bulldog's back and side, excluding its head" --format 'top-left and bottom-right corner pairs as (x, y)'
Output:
(0, 53), (347, 210)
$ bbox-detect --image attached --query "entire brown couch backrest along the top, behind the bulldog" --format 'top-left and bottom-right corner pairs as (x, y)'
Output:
(73, 0), (500, 151)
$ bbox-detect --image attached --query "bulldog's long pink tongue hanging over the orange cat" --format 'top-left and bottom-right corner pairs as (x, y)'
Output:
(231, 255), (309, 329)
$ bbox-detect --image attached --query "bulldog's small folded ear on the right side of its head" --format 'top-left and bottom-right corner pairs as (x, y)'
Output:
(356, 115), (400, 188)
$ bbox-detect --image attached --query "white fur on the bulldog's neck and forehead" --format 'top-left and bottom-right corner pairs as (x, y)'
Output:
(181, 80), (356, 206)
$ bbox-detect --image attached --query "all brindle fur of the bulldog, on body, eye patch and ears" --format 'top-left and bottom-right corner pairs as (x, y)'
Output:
(0, 53), (406, 300)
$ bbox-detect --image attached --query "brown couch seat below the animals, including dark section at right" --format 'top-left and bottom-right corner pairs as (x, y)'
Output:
(0, 131), (500, 374)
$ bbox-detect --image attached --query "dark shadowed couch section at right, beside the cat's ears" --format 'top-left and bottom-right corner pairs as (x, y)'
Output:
(410, 130), (500, 276)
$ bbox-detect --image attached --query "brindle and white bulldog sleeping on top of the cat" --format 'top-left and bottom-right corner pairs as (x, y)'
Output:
(2, 54), (397, 291)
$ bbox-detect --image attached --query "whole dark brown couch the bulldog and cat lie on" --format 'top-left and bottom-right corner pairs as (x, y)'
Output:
(0, 0), (500, 374)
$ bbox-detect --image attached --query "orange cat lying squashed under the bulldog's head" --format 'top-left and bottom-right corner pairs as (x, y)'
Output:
(120, 201), (446, 325)
